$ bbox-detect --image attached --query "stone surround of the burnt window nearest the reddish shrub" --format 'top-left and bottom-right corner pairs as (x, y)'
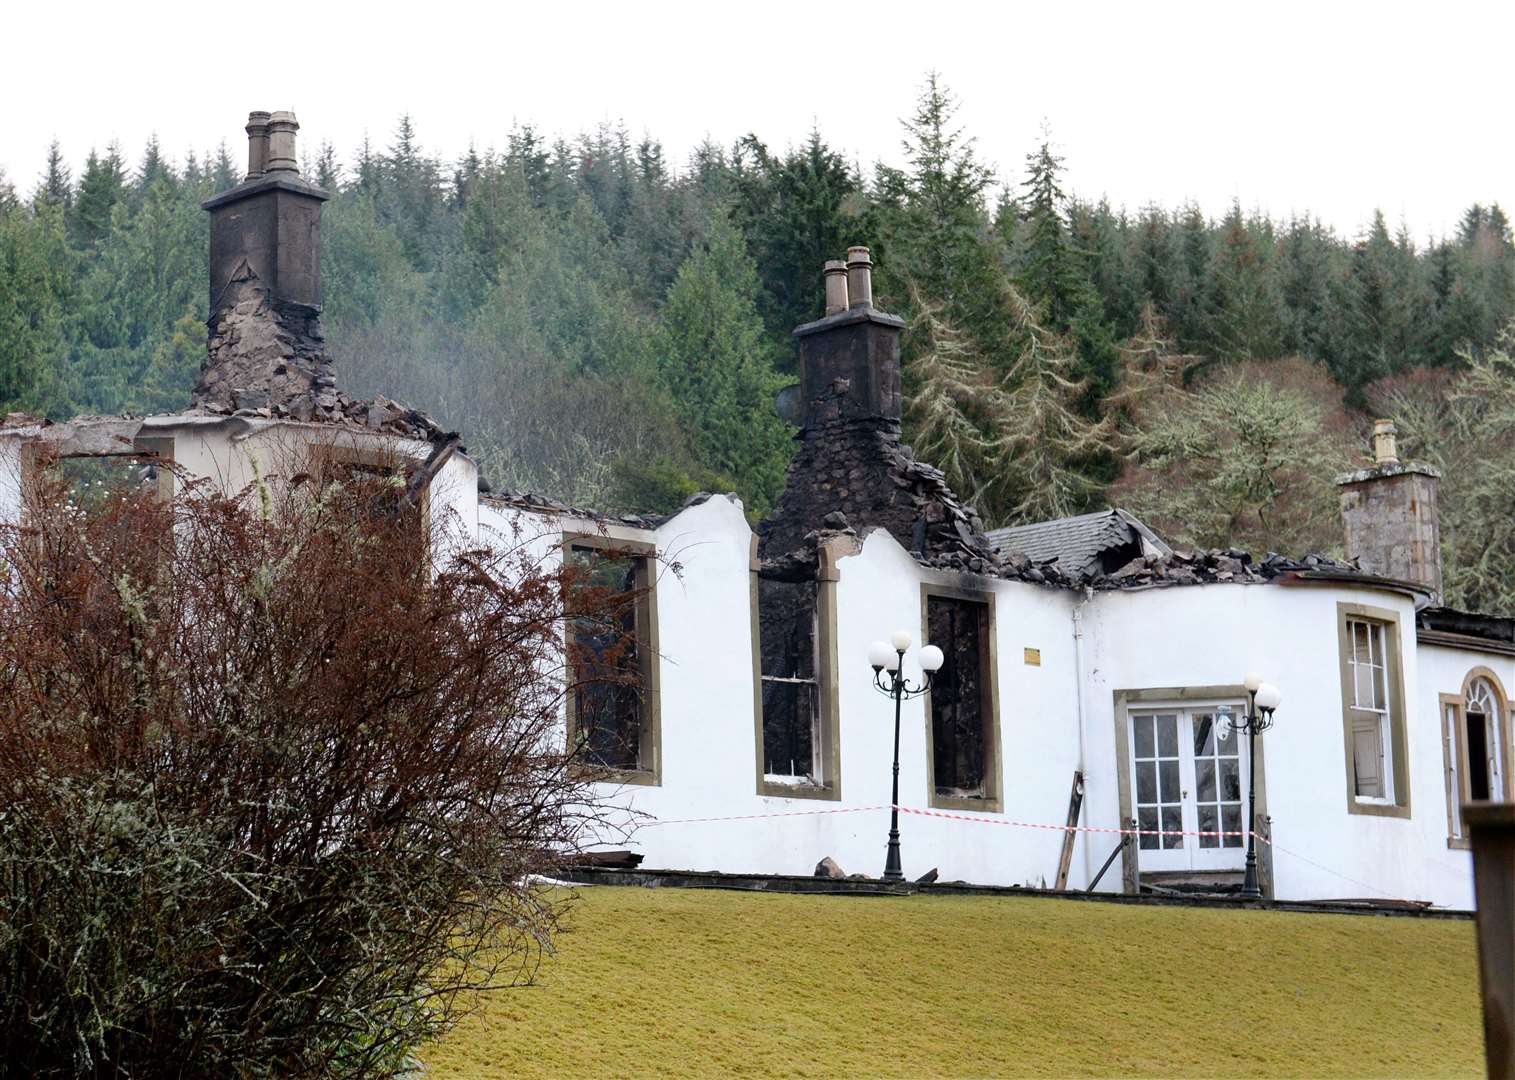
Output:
(559, 529), (662, 788)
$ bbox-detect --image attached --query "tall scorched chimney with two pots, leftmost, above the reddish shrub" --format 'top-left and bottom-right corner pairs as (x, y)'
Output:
(194, 112), (336, 418)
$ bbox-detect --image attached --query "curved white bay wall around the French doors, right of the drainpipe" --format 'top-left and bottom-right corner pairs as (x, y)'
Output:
(1089, 585), (1471, 907)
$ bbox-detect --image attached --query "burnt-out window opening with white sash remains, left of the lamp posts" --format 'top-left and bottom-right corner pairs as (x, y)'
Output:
(758, 579), (826, 785)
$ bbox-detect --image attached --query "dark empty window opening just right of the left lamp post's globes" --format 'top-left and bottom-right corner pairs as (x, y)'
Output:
(926, 597), (994, 798)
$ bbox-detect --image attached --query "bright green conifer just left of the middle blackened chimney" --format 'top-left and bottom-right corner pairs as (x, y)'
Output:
(658, 215), (792, 513)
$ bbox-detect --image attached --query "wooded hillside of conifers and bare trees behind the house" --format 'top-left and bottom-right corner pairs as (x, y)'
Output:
(0, 77), (1515, 609)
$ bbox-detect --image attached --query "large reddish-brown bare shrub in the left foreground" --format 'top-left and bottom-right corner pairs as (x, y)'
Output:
(0, 445), (615, 1077)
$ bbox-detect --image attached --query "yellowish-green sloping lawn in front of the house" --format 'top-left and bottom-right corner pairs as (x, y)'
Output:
(423, 886), (1483, 1078)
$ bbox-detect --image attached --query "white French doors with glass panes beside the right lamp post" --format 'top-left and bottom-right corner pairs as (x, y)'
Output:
(1130, 704), (1247, 871)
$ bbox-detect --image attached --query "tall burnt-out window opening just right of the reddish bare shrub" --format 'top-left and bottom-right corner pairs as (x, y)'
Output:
(568, 542), (654, 773)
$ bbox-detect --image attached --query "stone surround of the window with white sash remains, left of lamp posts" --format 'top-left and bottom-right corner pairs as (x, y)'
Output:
(747, 536), (857, 803)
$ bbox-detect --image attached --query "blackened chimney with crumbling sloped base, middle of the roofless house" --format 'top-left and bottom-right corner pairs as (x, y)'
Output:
(758, 247), (994, 570)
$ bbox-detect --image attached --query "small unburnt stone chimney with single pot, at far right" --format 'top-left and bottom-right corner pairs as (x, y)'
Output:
(1336, 420), (1441, 603)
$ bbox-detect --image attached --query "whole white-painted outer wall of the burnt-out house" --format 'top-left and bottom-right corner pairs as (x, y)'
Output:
(0, 417), (1490, 907)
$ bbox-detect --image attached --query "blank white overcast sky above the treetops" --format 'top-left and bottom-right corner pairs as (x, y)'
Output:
(0, 0), (1515, 238)
